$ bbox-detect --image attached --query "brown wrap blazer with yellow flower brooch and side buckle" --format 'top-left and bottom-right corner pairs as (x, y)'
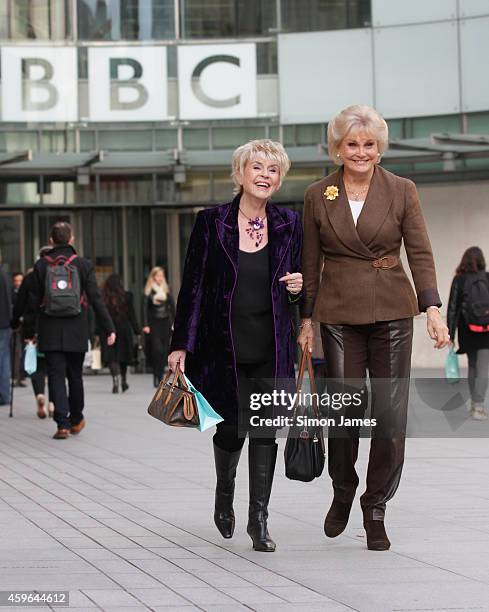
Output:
(301, 166), (441, 325)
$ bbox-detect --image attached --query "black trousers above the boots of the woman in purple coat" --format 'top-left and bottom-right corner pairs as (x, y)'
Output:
(213, 360), (276, 453)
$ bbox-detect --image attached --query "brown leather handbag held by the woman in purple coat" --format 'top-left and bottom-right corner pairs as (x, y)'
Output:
(148, 367), (199, 427)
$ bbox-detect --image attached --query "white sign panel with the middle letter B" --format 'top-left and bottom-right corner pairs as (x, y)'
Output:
(88, 46), (168, 121)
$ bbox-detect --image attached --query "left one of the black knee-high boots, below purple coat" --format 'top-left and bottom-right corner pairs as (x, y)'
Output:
(214, 444), (241, 538)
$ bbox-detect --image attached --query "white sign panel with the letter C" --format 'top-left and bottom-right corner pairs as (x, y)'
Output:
(178, 43), (257, 119)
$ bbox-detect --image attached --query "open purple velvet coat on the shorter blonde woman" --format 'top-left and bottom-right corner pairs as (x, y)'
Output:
(170, 197), (302, 423)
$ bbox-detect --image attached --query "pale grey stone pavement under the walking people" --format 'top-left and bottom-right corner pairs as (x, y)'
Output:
(0, 375), (489, 612)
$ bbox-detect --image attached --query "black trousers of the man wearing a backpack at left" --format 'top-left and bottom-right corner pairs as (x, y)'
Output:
(45, 351), (85, 429)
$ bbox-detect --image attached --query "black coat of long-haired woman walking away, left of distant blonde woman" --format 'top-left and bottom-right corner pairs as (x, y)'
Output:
(102, 291), (141, 364)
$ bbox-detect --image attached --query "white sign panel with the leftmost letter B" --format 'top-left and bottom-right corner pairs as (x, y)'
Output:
(2, 46), (78, 122)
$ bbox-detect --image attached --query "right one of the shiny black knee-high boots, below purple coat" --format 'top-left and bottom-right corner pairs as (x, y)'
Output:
(247, 444), (278, 552)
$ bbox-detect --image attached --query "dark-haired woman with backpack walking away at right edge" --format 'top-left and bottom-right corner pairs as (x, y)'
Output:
(447, 247), (489, 421)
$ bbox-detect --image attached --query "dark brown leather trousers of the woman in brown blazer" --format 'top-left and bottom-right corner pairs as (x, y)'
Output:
(321, 319), (413, 520)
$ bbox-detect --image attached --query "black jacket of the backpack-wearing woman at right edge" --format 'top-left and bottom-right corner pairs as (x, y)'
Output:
(447, 272), (489, 355)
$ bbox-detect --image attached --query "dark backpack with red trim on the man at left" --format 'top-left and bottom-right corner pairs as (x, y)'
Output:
(44, 255), (82, 317)
